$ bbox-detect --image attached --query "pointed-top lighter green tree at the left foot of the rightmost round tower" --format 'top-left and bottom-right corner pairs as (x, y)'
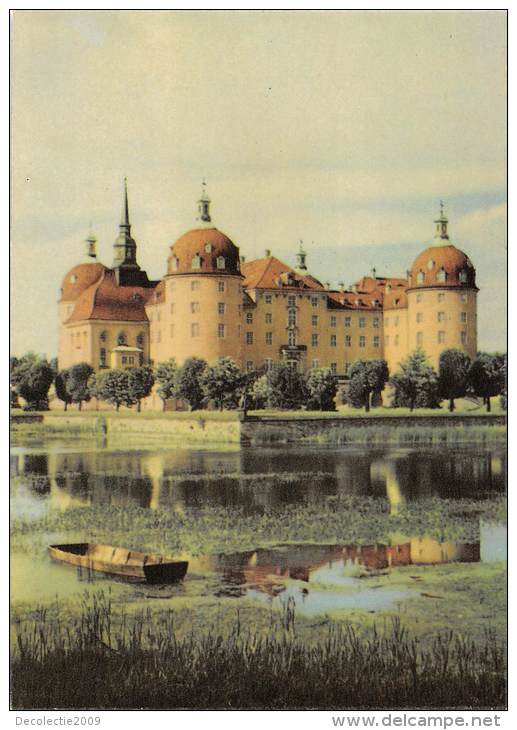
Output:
(390, 350), (440, 411)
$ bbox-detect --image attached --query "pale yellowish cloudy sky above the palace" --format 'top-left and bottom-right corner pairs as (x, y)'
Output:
(11, 10), (507, 357)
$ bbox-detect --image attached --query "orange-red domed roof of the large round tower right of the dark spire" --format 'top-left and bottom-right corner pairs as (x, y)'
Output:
(167, 227), (240, 275)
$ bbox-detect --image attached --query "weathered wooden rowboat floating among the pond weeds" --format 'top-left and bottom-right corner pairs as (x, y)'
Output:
(48, 542), (188, 583)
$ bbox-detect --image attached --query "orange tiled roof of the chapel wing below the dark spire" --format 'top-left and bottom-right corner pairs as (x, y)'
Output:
(67, 270), (153, 324)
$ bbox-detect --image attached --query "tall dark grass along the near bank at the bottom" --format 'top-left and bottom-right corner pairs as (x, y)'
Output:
(11, 594), (505, 709)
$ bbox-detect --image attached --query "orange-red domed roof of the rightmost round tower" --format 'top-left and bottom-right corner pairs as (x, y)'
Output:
(409, 243), (476, 288)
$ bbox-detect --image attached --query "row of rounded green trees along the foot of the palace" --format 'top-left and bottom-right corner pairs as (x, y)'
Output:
(10, 349), (507, 411)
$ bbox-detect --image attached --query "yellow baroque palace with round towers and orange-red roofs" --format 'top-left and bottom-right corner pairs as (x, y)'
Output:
(58, 185), (478, 376)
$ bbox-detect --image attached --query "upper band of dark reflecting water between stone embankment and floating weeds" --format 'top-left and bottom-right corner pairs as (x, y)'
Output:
(11, 442), (506, 514)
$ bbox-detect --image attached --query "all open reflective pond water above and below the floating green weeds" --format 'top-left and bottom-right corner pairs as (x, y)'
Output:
(11, 438), (506, 615)
